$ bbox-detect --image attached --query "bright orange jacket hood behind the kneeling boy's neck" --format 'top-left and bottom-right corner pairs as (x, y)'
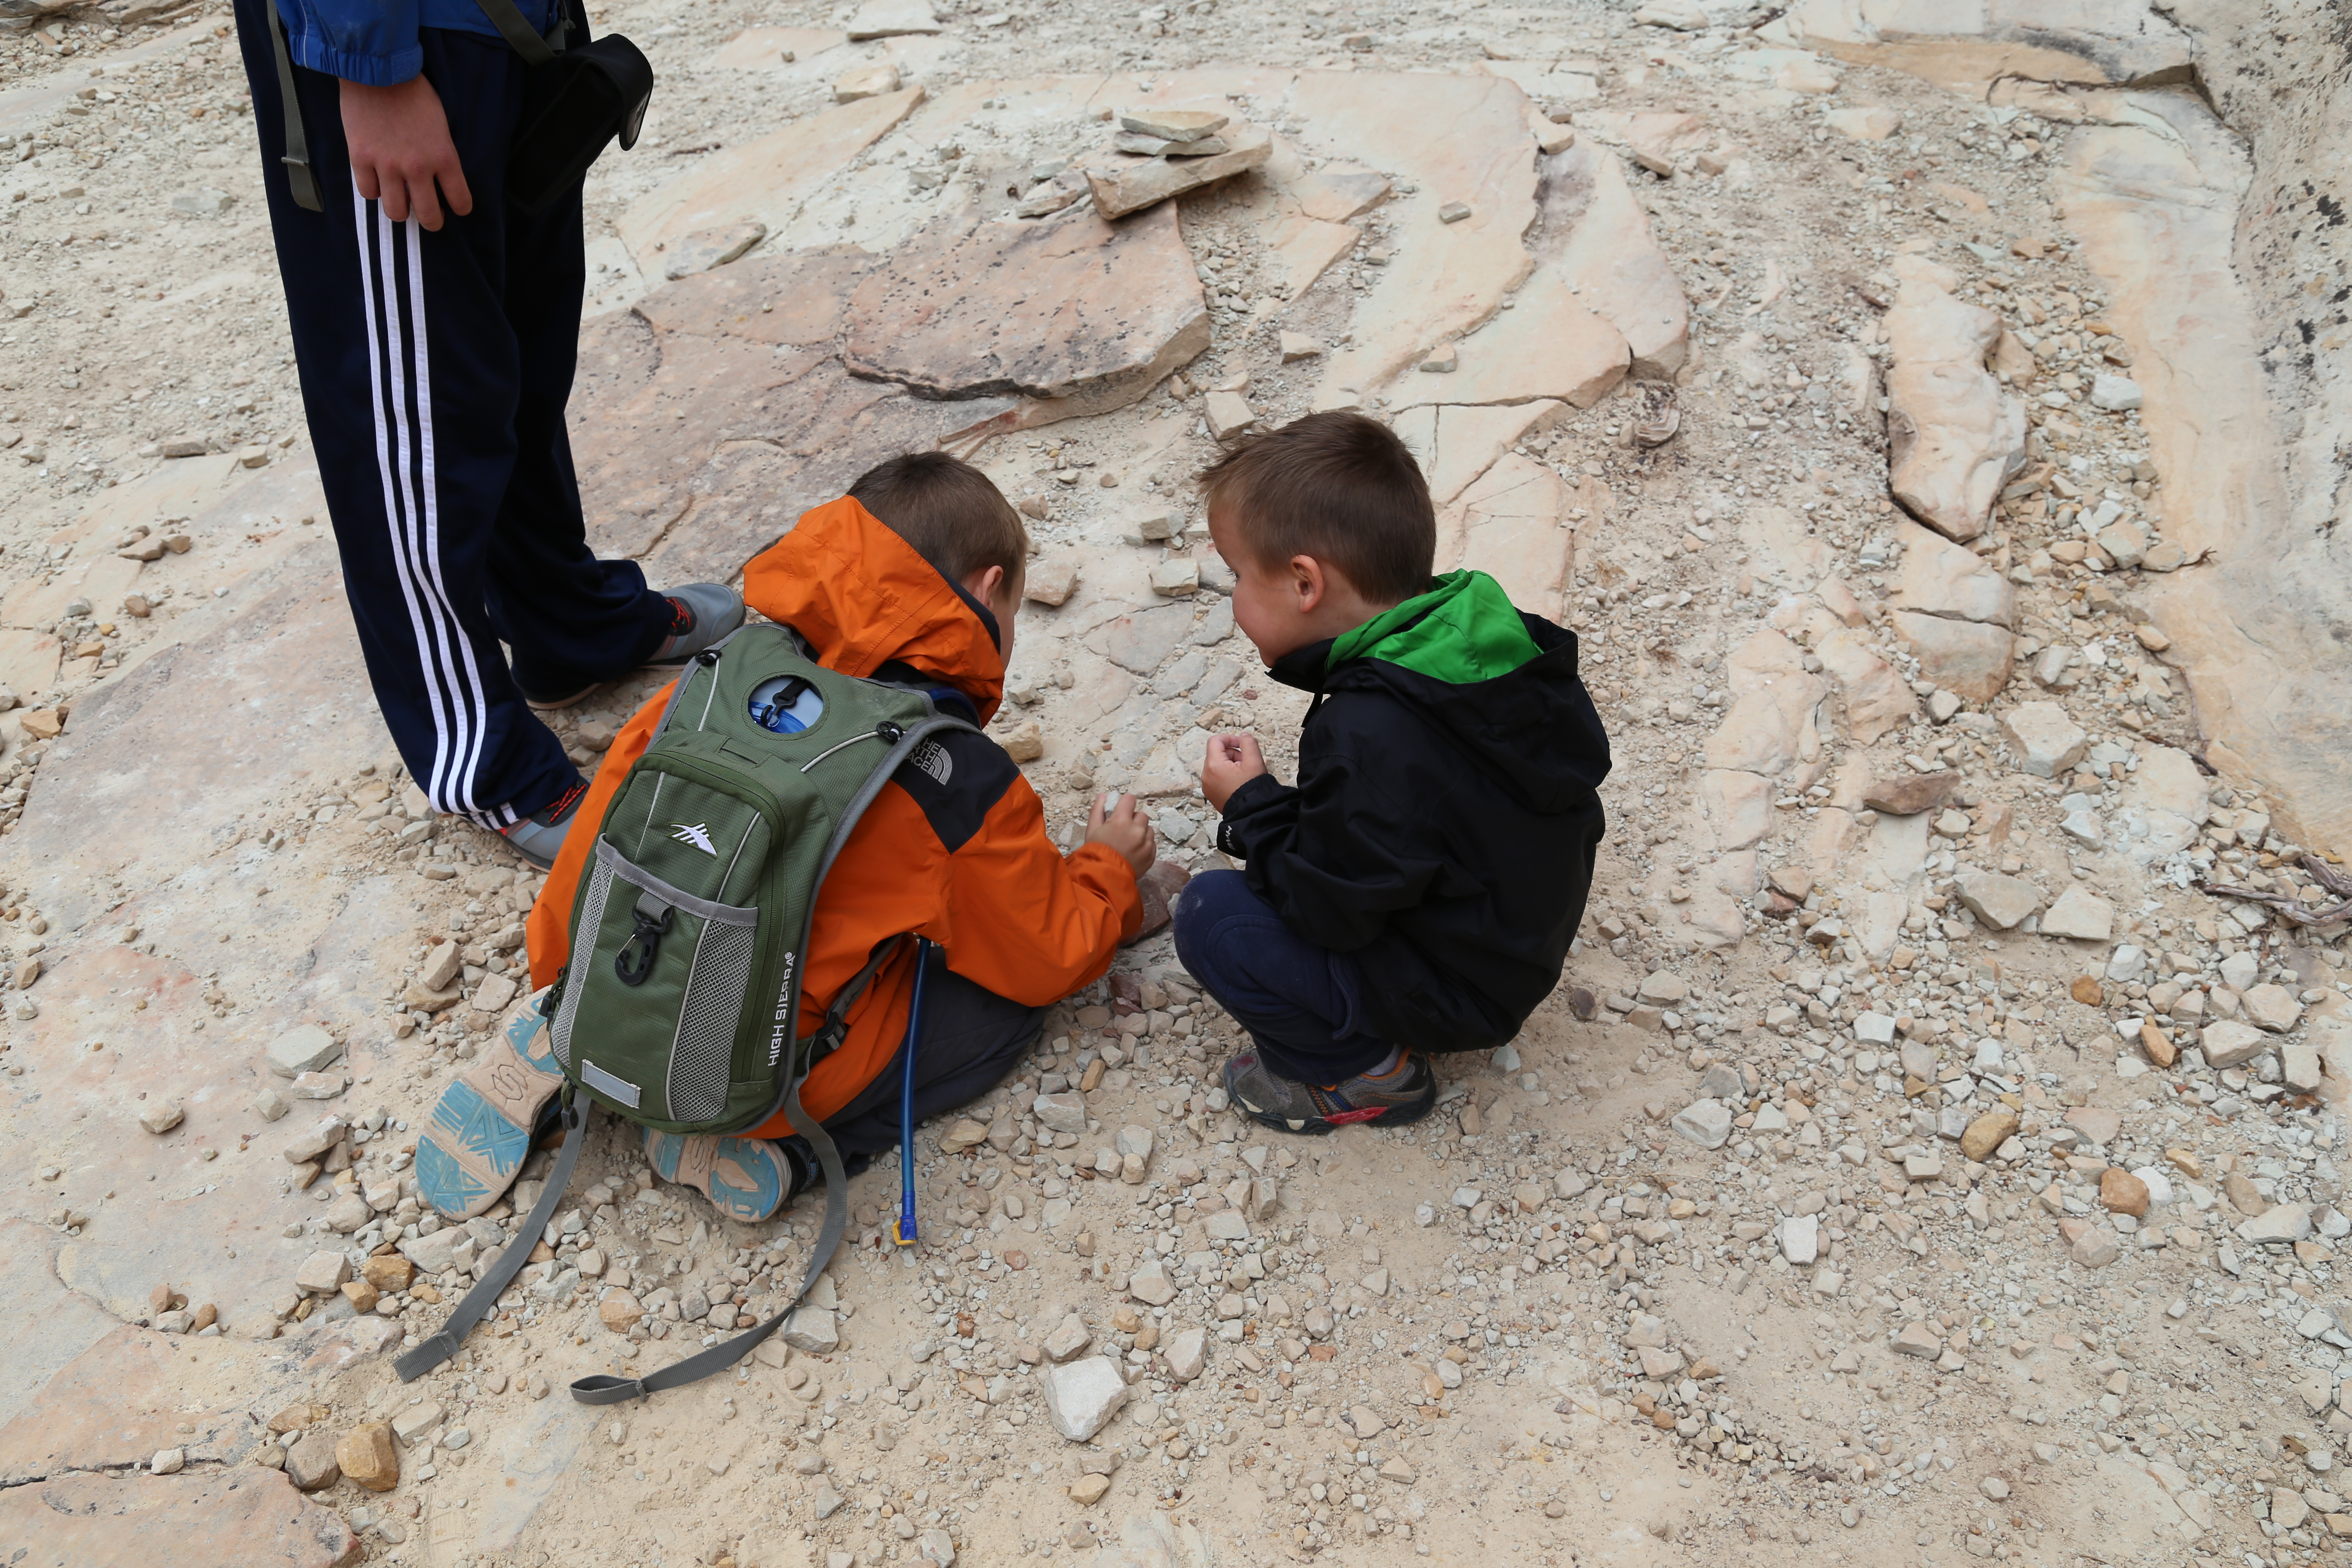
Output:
(743, 496), (1004, 724)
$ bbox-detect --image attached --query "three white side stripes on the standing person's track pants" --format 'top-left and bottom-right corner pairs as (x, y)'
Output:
(350, 190), (518, 827)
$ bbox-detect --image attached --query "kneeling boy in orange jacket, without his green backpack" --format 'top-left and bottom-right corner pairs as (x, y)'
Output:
(416, 451), (1155, 1220)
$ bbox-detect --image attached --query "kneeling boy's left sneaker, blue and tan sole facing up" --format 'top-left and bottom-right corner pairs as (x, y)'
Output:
(416, 992), (564, 1220)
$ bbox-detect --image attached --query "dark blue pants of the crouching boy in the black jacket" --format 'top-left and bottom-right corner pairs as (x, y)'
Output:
(1176, 872), (1387, 1086)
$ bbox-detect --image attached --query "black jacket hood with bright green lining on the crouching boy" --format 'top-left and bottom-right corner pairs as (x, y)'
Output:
(1270, 571), (1609, 813)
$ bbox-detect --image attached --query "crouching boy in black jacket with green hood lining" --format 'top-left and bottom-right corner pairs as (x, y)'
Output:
(1176, 414), (1609, 1133)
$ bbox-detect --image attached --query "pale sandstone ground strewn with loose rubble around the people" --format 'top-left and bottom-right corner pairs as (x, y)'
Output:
(0, 0), (2352, 1568)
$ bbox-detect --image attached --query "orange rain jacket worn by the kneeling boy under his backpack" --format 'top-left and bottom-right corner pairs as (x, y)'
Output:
(529, 496), (1143, 1138)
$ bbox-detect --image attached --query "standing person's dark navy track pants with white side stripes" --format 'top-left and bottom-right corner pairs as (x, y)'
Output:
(235, 0), (671, 827)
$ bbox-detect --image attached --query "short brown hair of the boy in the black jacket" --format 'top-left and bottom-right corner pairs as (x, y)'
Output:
(1200, 411), (1437, 604)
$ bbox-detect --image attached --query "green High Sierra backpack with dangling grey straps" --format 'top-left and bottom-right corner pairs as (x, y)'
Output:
(398, 623), (978, 1403)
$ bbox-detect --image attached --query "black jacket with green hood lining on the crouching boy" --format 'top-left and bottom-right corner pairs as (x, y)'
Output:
(1216, 571), (1609, 1051)
